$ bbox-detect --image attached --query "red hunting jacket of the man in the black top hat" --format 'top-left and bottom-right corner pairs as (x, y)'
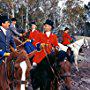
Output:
(33, 33), (58, 63)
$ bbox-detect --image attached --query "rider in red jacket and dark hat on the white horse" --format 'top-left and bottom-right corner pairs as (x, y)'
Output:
(62, 27), (72, 45)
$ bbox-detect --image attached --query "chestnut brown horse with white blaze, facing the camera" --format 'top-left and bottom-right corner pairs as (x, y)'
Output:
(7, 46), (31, 90)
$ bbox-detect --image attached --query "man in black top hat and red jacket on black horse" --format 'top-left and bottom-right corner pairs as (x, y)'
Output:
(33, 19), (58, 64)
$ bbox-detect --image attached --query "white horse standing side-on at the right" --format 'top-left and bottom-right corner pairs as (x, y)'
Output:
(58, 38), (89, 70)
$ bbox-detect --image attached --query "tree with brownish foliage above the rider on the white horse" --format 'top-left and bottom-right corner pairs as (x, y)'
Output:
(61, 0), (85, 34)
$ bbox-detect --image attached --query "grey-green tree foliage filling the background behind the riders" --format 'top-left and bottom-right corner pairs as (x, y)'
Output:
(0, 0), (88, 35)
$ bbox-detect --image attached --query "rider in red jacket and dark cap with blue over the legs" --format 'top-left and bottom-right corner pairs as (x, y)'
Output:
(24, 21), (40, 54)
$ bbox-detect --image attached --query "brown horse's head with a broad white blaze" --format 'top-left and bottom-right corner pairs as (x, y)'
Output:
(7, 50), (31, 90)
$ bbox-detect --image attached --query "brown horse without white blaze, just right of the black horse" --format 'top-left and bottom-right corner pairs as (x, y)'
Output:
(55, 47), (72, 90)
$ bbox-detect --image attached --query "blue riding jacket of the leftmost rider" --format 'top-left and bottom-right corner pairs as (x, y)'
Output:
(0, 28), (16, 56)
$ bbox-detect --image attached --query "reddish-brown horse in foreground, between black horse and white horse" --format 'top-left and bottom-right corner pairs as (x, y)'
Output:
(58, 49), (72, 90)
